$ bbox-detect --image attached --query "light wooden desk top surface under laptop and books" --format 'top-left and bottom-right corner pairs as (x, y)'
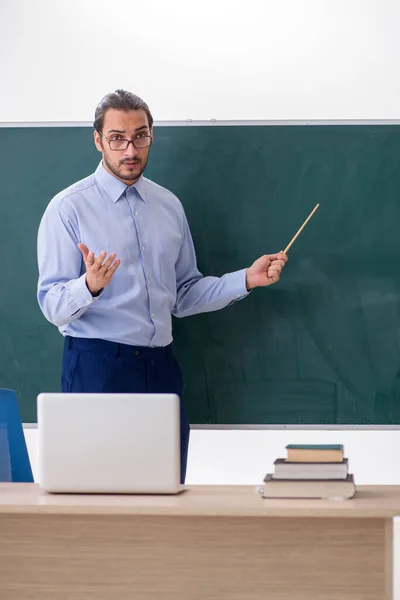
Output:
(0, 483), (400, 518)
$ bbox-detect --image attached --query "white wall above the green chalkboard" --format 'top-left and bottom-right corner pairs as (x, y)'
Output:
(0, 0), (400, 122)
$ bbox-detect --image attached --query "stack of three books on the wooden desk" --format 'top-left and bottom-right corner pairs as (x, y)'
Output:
(263, 444), (355, 499)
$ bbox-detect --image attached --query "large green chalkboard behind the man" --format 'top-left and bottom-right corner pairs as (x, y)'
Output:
(0, 125), (400, 424)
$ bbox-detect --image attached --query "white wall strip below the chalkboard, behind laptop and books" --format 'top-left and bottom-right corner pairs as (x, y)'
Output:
(24, 426), (400, 485)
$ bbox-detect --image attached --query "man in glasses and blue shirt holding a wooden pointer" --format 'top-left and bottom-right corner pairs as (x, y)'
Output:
(38, 90), (287, 483)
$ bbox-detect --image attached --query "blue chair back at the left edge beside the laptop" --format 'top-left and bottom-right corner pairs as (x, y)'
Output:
(0, 389), (33, 483)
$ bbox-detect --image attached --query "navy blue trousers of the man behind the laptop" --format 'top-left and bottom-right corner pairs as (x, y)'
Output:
(61, 336), (190, 483)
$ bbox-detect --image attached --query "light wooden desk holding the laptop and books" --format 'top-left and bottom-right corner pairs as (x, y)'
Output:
(0, 484), (400, 600)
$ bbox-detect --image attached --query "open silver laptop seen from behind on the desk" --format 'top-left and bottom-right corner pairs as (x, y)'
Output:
(37, 393), (184, 494)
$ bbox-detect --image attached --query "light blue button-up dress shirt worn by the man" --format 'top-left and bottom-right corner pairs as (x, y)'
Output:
(38, 163), (247, 346)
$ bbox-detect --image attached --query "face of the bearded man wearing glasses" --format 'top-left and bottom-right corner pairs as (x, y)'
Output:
(94, 108), (152, 185)
